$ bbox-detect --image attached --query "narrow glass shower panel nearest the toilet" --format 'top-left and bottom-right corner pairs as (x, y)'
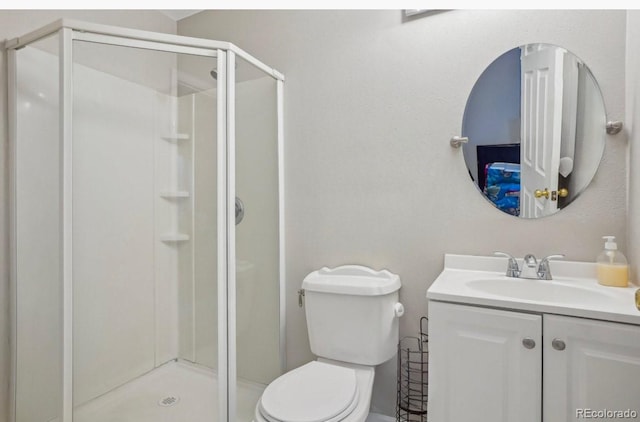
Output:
(234, 54), (282, 422)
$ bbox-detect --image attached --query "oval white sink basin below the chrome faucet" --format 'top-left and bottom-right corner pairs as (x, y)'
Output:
(467, 278), (607, 303)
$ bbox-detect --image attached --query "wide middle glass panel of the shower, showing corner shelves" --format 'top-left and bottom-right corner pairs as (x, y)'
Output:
(72, 36), (219, 422)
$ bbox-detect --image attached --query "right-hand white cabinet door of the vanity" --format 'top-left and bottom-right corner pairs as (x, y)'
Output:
(543, 315), (640, 422)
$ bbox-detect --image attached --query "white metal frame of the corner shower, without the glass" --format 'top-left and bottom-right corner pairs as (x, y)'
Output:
(5, 19), (286, 422)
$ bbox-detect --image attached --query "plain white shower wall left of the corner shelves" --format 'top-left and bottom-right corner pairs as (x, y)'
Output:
(73, 54), (177, 405)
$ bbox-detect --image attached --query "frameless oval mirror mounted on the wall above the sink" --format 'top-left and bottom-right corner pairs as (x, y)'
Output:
(462, 44), (606, 218)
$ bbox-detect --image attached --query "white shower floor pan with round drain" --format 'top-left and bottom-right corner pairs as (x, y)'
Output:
(73, 361), (264, 422)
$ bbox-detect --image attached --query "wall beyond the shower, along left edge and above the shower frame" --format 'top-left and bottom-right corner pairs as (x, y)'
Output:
(0, 10), (176, 422)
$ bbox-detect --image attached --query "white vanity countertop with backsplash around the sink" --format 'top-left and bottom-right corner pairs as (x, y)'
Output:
(427, 254), (640, 325)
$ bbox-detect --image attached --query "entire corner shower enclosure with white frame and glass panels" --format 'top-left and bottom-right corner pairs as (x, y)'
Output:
(6, 20), (284, 422)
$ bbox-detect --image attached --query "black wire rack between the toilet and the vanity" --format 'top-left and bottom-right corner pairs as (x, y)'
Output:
(396, 317), (429, 422)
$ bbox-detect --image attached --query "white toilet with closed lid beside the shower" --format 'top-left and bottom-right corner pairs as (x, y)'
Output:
(255, 265), (404, 422)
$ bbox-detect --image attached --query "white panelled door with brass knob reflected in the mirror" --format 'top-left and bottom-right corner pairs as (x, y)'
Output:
(520, 44), (565, 218)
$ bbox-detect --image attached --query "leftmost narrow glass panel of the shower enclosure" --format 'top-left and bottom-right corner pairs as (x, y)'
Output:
(13, 35), (63, 422)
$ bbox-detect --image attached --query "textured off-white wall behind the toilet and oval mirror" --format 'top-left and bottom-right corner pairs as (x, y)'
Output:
(178, 10), (627, 415)
